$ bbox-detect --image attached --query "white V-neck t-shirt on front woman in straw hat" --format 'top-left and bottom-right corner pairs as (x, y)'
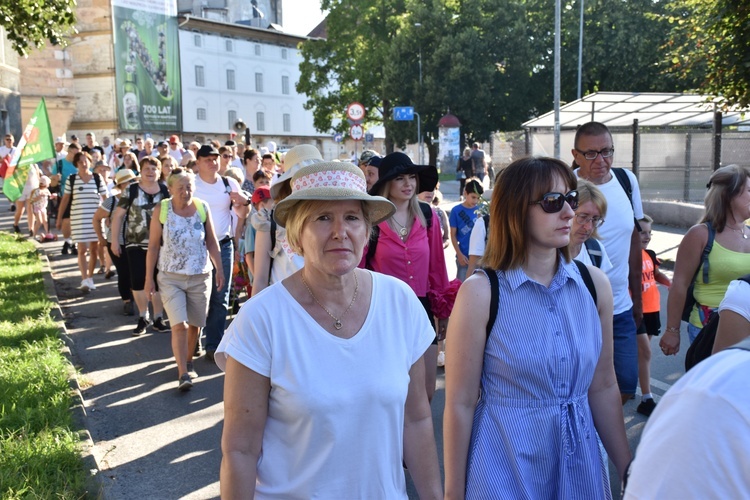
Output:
(215, 271), (435, 499)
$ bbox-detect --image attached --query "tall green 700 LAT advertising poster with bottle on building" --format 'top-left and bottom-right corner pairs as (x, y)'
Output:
(112, 0), (182, 132)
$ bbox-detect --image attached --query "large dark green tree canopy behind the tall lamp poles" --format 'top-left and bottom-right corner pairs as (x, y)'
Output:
(297, 0), (712, 155)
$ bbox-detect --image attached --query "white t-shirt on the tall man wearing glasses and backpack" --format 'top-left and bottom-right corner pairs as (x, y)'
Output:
(575, 170), (643, 314)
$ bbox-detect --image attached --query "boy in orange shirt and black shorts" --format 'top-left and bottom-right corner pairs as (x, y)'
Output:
(636, 214), (672, 417)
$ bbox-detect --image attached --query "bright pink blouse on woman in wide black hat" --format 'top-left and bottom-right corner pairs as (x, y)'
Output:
(359, 209), (455, 319)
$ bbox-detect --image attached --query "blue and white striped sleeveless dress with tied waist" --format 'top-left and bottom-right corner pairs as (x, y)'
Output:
(466, 262), (611, 500)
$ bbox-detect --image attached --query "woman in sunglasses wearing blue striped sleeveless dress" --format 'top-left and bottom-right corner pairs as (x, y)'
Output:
(443, 158), (630, 499)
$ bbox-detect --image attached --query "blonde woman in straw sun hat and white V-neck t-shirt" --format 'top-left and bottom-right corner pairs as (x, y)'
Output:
(214, 162), (443, 499)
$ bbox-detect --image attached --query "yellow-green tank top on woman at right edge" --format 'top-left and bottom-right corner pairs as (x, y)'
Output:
(690, 241), (750, 328)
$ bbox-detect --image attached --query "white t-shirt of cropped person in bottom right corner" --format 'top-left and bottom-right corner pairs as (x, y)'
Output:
(624, 349), (750, 499)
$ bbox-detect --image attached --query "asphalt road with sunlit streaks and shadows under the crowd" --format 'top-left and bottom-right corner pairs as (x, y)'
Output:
(0, 181), (686, 499)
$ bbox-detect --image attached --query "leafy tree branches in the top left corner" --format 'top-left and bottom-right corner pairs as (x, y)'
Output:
(0, 0), (76, 56)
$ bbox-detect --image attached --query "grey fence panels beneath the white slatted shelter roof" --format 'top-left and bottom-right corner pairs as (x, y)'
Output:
(500, 128), (750, 203)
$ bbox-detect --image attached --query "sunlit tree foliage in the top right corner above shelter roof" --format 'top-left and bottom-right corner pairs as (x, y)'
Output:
(664, 0), (750, 109)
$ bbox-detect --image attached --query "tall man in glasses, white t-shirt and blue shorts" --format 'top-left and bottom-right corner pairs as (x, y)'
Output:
(572, 122), (643, 404)
